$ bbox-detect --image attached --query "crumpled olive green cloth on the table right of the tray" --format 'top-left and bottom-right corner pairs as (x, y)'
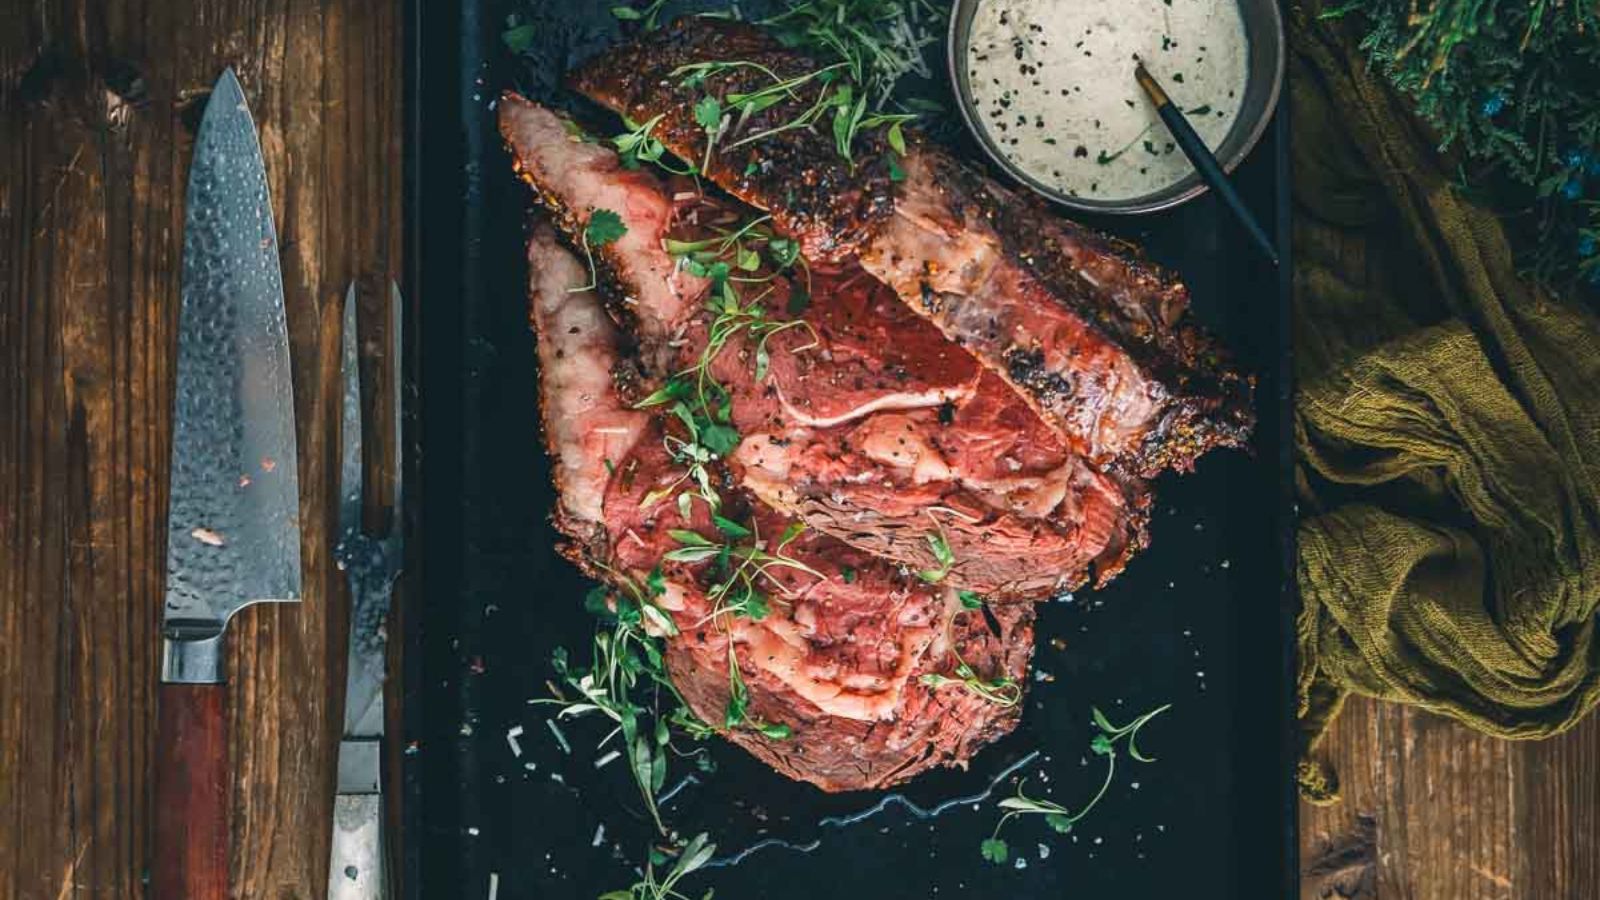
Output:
(1290, 0), (1600, 801)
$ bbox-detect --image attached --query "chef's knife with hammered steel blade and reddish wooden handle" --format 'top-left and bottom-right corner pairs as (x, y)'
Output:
(150, 69), (301, 900)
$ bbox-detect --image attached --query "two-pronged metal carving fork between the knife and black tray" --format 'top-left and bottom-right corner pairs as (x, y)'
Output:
(328, 283), (405, 900)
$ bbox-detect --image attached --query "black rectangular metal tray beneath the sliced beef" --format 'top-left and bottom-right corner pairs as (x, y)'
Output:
(402, 0), (1296, 900)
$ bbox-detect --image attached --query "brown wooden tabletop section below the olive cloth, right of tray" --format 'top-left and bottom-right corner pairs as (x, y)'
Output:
(1301, 700), (1600, 900)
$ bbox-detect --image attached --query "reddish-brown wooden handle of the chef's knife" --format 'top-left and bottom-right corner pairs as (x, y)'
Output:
(150, 684), (230, 900)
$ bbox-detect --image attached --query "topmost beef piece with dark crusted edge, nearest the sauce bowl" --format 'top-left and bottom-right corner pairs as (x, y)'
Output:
(573, 18), (1253, 476)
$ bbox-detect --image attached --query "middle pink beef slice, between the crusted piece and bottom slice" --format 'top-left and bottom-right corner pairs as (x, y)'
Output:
(501, 96), (1147, 599)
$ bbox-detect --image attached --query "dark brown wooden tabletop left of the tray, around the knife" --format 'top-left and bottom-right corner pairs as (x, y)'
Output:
(0, 0), (403, 900)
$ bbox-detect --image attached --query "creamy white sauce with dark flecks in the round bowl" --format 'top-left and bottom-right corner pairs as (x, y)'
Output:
(963, 0), (1250, 200)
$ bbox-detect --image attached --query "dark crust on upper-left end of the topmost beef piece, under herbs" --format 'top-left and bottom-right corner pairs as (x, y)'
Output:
(571, 16), (894, 263)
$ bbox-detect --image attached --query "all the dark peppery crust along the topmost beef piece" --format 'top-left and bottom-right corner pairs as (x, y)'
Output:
(571, 18), (1254, 476)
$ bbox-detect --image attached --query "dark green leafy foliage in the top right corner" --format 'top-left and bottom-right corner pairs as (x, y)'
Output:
(1323, 0), (1600, 287)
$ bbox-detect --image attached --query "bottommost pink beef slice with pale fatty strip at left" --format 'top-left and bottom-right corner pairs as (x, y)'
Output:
(530, 229), (1032, 791)
